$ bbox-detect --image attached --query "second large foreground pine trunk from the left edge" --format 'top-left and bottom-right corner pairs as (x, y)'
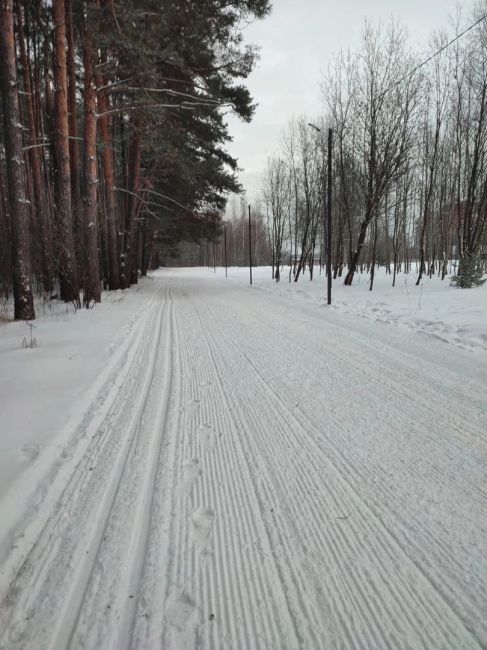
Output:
(52, 0), (80, 306)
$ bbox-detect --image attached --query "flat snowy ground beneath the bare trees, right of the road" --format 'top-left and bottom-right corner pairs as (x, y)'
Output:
(222, 267), (487, 350)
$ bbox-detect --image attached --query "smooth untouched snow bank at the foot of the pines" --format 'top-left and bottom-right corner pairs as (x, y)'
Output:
(0, 280), (150, 500)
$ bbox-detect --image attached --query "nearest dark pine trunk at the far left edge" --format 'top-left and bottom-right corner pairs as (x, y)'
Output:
(0, 0), (35, 320)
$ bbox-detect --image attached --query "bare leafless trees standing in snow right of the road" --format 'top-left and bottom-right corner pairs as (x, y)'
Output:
(264, 8), (487, 289)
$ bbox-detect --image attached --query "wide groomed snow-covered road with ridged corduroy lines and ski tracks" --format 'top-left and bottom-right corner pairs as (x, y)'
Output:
(0, 270), (487, 650)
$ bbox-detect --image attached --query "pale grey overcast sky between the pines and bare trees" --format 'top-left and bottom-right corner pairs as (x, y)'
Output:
(229, 0), (471, 202)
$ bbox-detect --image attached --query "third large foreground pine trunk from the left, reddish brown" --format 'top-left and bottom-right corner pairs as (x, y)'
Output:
(83, 2), (101, 307)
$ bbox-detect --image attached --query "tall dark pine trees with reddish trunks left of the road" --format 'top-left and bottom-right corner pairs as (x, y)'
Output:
(0, 0), (270, 319)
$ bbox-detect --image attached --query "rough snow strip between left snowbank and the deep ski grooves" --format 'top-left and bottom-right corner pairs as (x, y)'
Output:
(0, 280), (172, 648)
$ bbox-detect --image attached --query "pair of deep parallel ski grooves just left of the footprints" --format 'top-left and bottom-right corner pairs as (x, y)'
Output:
(70, 284), (174, 650)
